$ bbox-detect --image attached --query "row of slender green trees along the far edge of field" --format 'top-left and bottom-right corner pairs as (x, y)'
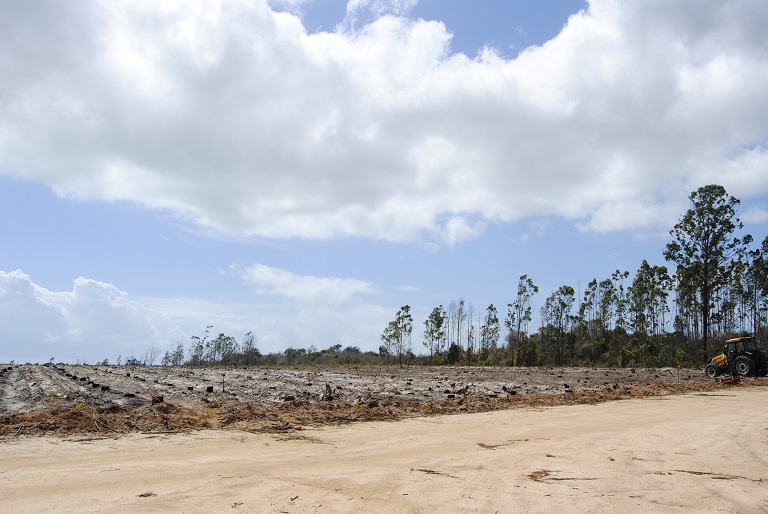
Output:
(132, 184), (768, 367)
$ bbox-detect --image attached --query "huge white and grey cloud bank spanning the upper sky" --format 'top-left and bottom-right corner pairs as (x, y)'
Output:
(0, 0), (768, 244)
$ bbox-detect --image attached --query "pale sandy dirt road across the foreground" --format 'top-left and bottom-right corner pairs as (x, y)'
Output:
(0, 386), (768, 513)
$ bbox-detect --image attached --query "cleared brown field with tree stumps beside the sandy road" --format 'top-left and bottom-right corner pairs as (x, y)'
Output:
(0, 364), (768, 438)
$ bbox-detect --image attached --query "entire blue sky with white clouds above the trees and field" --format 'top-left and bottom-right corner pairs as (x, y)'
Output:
(0, 0), (768, 363)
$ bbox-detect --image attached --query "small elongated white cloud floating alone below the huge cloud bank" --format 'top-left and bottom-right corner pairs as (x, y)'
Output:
(232, 264), (377, 304)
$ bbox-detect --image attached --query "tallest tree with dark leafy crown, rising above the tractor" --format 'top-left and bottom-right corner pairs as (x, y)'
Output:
(664, 184), (752, 353)
